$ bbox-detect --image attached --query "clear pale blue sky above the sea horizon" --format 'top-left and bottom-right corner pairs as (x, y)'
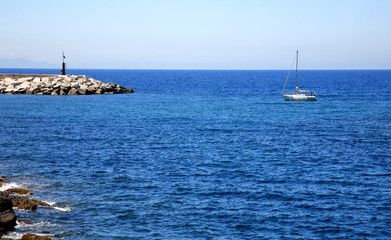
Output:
(0, 0), (391, 70)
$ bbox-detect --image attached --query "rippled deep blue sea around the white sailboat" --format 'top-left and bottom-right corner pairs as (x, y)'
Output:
(0, 69), (391, 239)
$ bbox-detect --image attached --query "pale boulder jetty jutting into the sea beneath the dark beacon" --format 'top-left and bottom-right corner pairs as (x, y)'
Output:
(0, 74), (133, 95)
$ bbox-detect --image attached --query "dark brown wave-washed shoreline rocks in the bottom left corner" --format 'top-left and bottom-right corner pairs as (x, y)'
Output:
(0, 176), (51, 240)
